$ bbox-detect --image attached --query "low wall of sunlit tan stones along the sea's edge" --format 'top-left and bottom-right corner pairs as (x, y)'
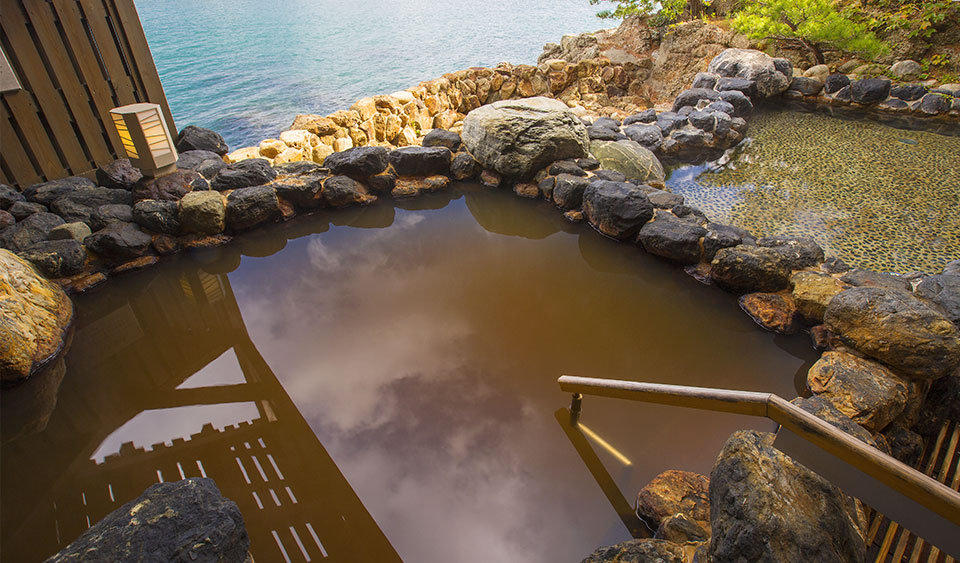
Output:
(226, 57), (639, 164)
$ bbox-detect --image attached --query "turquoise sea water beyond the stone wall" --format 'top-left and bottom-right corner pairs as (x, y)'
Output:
(136, 0), (615, 150)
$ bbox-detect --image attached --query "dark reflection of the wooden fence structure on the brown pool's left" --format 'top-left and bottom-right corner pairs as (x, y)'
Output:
(0, 270), (399, 561)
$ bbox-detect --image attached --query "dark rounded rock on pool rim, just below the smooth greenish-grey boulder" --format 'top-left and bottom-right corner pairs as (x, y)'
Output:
(583, 180), (653, 240)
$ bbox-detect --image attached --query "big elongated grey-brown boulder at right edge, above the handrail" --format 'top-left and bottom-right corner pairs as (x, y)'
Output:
(823, 287), (960, 379)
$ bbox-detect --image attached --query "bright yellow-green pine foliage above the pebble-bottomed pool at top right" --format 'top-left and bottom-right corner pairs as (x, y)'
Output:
(733, 0), (887, 64)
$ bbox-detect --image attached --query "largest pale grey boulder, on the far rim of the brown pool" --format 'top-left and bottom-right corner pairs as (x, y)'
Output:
(461, 97), (590, 179)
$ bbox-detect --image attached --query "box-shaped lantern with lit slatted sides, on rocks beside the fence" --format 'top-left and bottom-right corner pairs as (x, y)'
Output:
(110, 104), (177, 178)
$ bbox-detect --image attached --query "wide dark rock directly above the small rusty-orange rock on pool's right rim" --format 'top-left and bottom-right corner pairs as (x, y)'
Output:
(710, 244), (790, 293)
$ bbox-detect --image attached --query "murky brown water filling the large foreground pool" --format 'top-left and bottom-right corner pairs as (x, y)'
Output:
(0, 186), (815, 563)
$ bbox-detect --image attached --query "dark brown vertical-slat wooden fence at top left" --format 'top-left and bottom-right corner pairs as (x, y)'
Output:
(0, 0), (176, 187)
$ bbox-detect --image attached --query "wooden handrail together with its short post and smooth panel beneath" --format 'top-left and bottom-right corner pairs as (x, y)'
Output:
(558, 376), (960, 557)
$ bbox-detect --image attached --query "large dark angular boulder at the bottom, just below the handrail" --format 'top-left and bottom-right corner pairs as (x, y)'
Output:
(710, 430), (866, 563)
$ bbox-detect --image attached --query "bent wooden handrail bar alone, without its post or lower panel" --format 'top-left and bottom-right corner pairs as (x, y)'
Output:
(557, 375), (960, 543)
